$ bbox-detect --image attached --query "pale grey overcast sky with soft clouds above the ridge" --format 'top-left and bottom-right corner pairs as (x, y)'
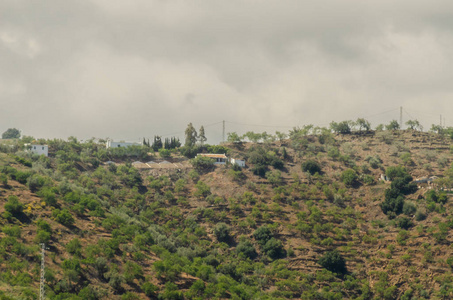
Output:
(0, 0), (453, 144)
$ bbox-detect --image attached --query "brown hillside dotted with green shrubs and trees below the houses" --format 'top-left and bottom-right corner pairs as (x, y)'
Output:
(0, 130), (453, 299)
